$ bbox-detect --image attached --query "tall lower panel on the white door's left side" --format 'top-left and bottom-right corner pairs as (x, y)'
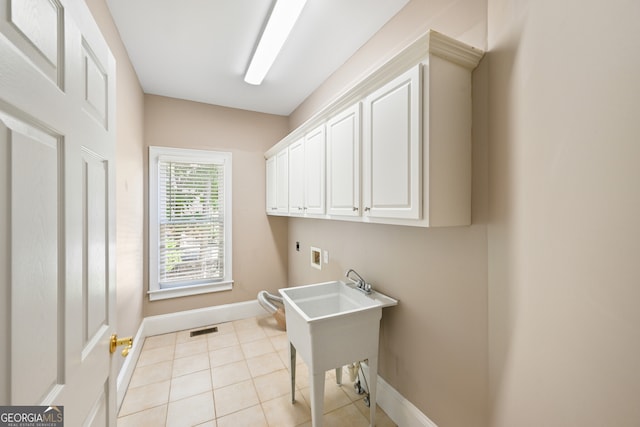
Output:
(0, 112), (64, 404)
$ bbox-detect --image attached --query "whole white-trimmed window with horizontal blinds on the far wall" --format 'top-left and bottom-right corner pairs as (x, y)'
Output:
(149, 147), (233, 301)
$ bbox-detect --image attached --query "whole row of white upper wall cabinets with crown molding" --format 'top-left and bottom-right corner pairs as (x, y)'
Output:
(266, 31), (483, 227)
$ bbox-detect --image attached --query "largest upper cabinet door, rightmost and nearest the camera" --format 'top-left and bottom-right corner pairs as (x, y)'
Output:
(362, 65), (422, 219)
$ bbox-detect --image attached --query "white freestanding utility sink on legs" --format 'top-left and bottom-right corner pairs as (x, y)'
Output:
(279, 281), (398, 427)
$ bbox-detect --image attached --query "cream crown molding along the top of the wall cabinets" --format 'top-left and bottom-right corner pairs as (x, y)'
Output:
(265, 30), (484, 158)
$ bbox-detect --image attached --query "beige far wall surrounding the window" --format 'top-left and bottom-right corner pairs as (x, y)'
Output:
(140, 95), (287, 316)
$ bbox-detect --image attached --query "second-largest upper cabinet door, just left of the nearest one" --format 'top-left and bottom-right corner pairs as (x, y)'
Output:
(327, 102), (361, 216)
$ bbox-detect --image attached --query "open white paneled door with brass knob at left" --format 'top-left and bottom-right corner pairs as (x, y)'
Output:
(0, 0), (119, 426)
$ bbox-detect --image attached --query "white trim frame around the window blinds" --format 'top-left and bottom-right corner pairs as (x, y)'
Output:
(147, 147), (233, 301)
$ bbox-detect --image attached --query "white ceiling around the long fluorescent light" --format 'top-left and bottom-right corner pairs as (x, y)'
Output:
(107, 0), (409, 115)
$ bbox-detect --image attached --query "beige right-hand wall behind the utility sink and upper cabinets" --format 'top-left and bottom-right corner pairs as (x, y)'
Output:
(289, 0), (488, 427)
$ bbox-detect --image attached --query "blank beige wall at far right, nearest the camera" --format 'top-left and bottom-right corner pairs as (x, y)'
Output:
(489, 0), (640, 427)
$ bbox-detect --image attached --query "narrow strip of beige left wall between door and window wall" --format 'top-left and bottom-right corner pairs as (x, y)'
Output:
(87, 0), (144, 372)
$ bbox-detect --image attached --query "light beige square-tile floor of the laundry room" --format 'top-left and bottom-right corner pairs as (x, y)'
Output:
(118, 315), (395, 427)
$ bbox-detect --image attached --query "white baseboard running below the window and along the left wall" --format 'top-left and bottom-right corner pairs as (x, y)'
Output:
(117, 300), (266, 411)
